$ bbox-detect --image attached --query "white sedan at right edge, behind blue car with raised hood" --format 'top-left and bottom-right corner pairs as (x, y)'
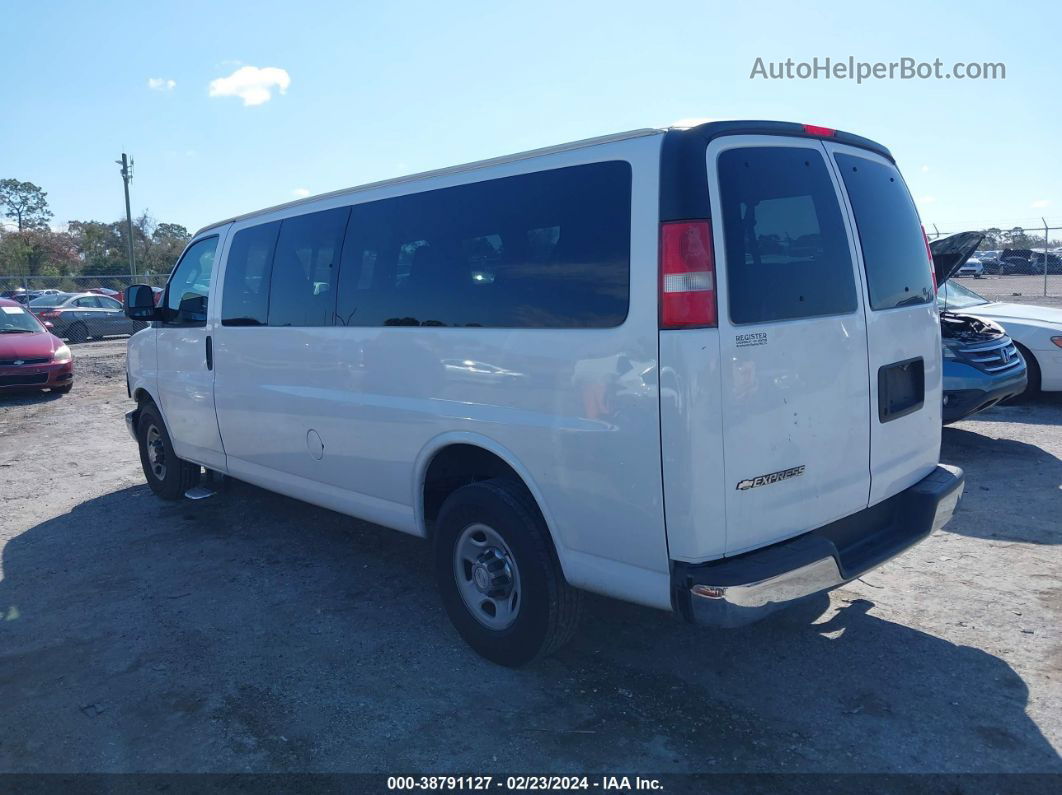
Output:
(937, 280), (1062, 395)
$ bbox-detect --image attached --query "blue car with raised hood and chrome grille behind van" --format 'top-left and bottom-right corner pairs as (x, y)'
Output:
(929, 231), (1027, 425)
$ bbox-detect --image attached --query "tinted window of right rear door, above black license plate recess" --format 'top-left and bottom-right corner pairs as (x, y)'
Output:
(835, 153), (933, 309)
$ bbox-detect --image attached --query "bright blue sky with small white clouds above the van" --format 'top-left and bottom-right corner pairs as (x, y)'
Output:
(0, 0), (1062, 231)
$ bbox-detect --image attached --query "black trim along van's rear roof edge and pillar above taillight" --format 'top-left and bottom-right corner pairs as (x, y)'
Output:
(661, 121), (895, 222)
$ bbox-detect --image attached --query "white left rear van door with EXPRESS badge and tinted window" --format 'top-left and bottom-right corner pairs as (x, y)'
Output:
(707, 136), (870, 555)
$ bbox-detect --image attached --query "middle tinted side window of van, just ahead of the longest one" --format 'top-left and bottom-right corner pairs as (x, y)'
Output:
(269, 207), (350, 326)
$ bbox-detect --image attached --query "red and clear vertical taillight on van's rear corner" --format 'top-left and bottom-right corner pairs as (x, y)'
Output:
(661, 221), (718, 328)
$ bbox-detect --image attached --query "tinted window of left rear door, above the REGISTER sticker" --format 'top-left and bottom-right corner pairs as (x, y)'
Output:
(719, 146), (858, 324)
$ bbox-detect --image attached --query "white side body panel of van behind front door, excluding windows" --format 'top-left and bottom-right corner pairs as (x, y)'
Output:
(210, 136), (670, 608)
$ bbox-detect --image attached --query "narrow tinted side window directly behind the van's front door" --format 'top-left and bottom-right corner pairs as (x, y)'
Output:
(221, 221), (280, 326)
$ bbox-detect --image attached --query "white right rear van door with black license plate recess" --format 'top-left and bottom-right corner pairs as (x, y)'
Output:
(824, 142), (941, 505)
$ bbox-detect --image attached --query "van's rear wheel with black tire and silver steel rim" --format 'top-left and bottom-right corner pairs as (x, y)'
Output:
(434, 479), (582, 668)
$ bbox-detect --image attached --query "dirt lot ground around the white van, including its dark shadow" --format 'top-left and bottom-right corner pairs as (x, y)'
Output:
(0, 342), (1062, 773)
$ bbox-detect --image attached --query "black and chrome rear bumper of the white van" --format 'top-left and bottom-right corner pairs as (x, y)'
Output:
(671, 464), (964, 627)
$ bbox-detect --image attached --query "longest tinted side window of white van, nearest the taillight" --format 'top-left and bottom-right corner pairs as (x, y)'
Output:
(336, 161), (631, 328)
